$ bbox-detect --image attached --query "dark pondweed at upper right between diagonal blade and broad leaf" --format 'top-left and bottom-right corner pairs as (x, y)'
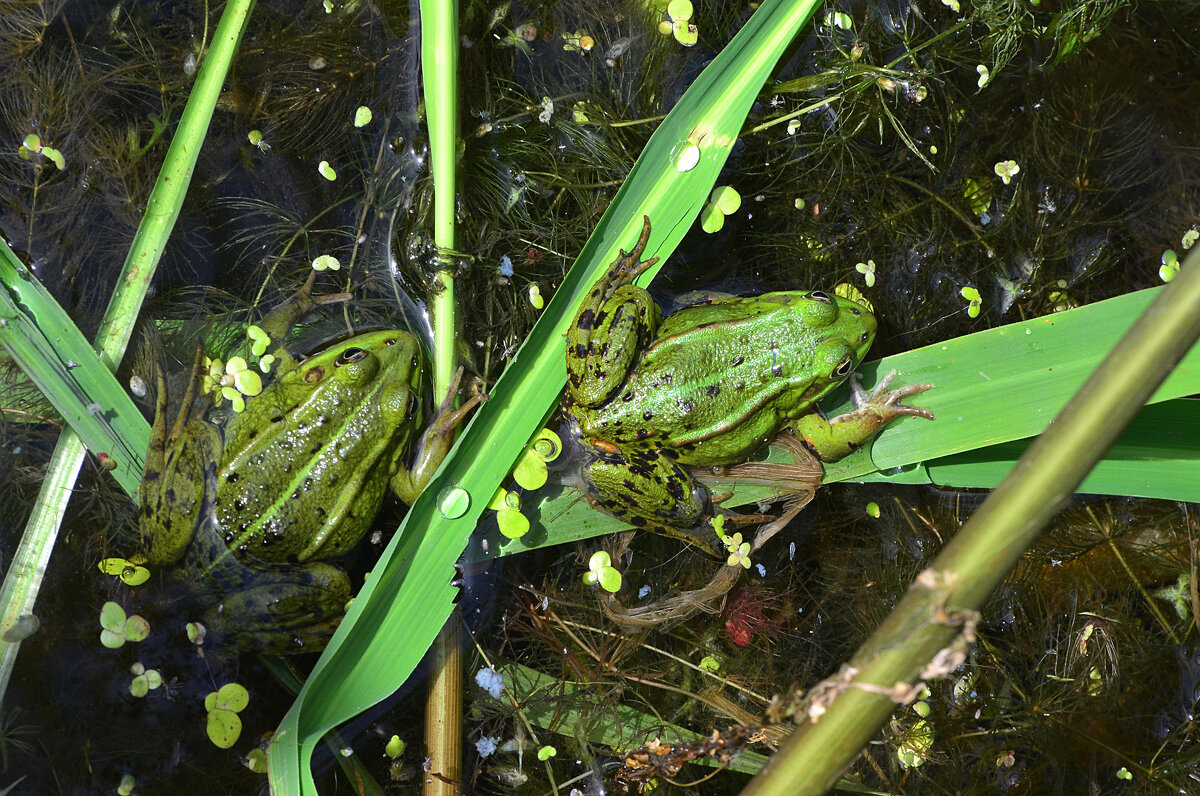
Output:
(662, 2), (1200, 353)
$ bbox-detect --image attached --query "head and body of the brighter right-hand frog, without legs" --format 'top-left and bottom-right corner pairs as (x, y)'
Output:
(588, 292), (875, 467)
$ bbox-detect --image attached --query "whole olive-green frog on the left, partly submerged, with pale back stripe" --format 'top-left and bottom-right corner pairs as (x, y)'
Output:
(139, 280), (480, 654)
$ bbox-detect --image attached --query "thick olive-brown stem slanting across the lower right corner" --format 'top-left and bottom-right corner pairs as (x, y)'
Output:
(743, 251), (1200, 796)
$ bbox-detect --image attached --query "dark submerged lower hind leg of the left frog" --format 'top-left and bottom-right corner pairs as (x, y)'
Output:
(204, 562), (350, 656)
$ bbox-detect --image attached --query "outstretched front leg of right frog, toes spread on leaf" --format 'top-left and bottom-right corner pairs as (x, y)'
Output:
(792, 371), (934, 461)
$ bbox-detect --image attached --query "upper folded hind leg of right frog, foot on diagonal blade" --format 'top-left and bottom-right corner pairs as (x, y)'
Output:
(566, 217), (659, 407)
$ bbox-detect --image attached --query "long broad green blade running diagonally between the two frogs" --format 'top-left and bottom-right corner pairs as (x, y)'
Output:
(270, 0), (817, 794)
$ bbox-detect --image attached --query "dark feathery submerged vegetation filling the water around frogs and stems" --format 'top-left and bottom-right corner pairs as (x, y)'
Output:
(0, 0), (1200, 794)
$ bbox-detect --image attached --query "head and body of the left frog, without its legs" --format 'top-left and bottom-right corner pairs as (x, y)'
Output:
(216, 331), (425, 563)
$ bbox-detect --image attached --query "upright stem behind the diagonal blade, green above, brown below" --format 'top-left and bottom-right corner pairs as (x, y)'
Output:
(420, 0), (463, 796)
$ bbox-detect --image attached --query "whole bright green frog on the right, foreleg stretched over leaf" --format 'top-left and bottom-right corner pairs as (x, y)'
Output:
(564, 219), (934, 551)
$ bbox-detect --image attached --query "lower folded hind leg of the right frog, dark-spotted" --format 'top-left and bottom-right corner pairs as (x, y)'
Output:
(582, 441), (716, 551)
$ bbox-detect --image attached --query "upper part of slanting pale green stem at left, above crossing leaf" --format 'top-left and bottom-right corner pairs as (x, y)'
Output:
(96, 0), (254, 370)
